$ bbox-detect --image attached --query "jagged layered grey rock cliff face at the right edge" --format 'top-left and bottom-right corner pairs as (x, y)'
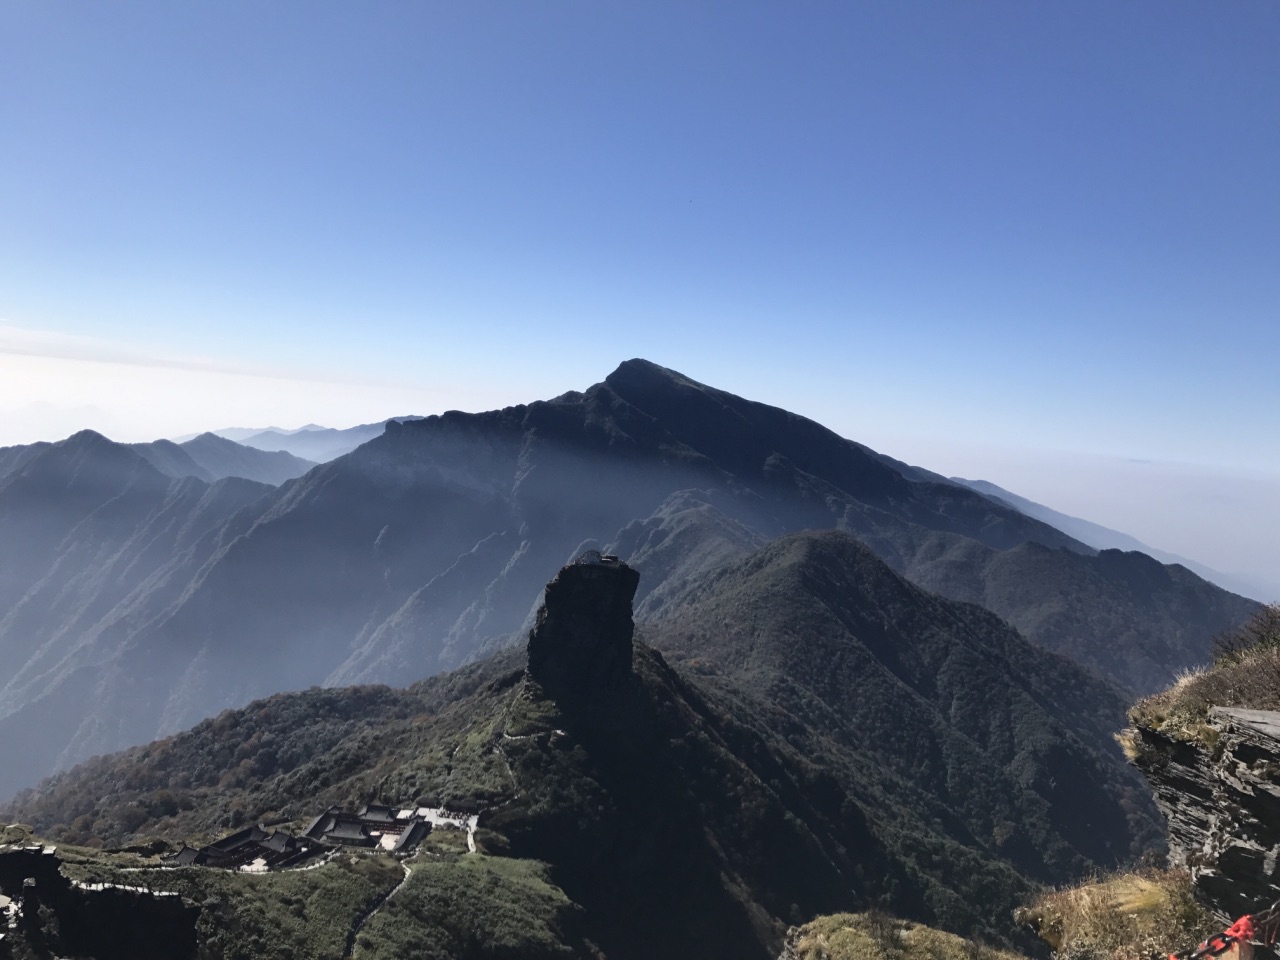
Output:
(1129, 707), (1280, 919)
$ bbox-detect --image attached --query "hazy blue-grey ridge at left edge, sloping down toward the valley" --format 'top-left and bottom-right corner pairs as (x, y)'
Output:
(0, 430), (271, 792)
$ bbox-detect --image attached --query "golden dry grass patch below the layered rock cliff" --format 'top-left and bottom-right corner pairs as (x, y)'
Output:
(1019, 870), (1217, 960)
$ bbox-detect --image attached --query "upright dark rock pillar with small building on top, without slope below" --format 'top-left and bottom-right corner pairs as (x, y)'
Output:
(529, 552), (640, 705)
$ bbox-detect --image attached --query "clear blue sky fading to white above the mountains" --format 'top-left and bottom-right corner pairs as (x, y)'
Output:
(0, 0), (1280, 591)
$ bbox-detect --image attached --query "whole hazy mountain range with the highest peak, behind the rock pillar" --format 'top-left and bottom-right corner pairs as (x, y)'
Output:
(0, 360), (1256, 795)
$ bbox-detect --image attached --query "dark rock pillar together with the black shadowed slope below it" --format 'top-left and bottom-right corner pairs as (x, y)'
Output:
(494, 550), (885, 960)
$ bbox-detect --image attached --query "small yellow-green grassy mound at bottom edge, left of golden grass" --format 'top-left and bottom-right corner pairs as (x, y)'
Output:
(791, 910), (1025, 960)
